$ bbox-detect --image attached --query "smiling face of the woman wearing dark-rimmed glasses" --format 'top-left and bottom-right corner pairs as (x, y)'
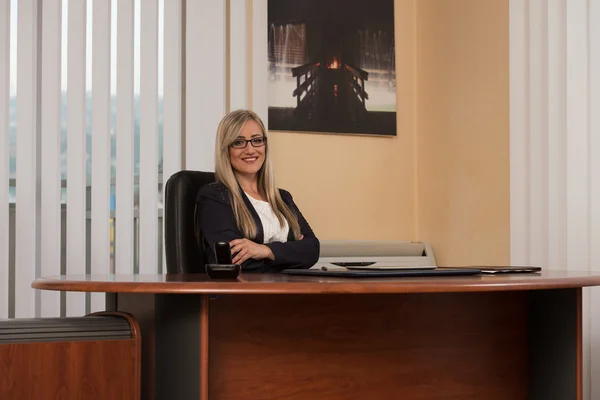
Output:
(229, 121), (266, 175)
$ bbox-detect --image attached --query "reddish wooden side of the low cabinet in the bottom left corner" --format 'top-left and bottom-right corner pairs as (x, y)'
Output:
(0, 340), (139, 400)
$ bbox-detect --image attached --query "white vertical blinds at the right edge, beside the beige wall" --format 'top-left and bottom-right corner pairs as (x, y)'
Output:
(510, 0), (600, 399)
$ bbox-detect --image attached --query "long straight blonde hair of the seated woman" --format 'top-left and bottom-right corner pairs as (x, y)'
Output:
(215, 110), (300, 239)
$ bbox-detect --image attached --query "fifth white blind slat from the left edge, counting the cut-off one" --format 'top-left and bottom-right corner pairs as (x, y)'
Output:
(90, 1), (111, 312)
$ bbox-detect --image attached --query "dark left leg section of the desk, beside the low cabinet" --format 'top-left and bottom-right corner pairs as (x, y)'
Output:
(117, 293), (208, 400)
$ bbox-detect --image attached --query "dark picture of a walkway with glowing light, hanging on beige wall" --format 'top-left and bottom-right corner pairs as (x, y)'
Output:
(268, 0), (396, 136)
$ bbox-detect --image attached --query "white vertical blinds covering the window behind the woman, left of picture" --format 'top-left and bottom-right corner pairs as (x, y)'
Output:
(0, 0), (267, 318)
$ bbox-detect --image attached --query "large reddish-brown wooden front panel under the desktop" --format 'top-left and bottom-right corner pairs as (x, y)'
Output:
(209, 292), (528, 400)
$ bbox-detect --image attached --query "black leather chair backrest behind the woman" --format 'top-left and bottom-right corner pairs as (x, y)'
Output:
(164, 171), (215, 274)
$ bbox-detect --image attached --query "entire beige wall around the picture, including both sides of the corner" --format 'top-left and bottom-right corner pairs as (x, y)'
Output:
(254, 0), (509, 264)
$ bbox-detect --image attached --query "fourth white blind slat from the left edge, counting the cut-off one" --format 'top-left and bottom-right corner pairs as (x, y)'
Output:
(66, 0), (87, 316)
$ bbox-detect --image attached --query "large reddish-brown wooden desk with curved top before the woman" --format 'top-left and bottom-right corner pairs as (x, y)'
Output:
(32, 271), (600, 400)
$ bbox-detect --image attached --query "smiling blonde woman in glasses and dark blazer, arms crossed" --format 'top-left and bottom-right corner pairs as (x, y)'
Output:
(196, 110), (320, 272)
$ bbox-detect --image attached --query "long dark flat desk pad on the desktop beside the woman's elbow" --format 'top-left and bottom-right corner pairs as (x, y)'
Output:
(281, 268), (480, 278)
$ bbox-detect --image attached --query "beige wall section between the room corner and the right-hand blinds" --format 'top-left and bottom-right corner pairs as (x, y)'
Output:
(417, 0), (510, 264)
